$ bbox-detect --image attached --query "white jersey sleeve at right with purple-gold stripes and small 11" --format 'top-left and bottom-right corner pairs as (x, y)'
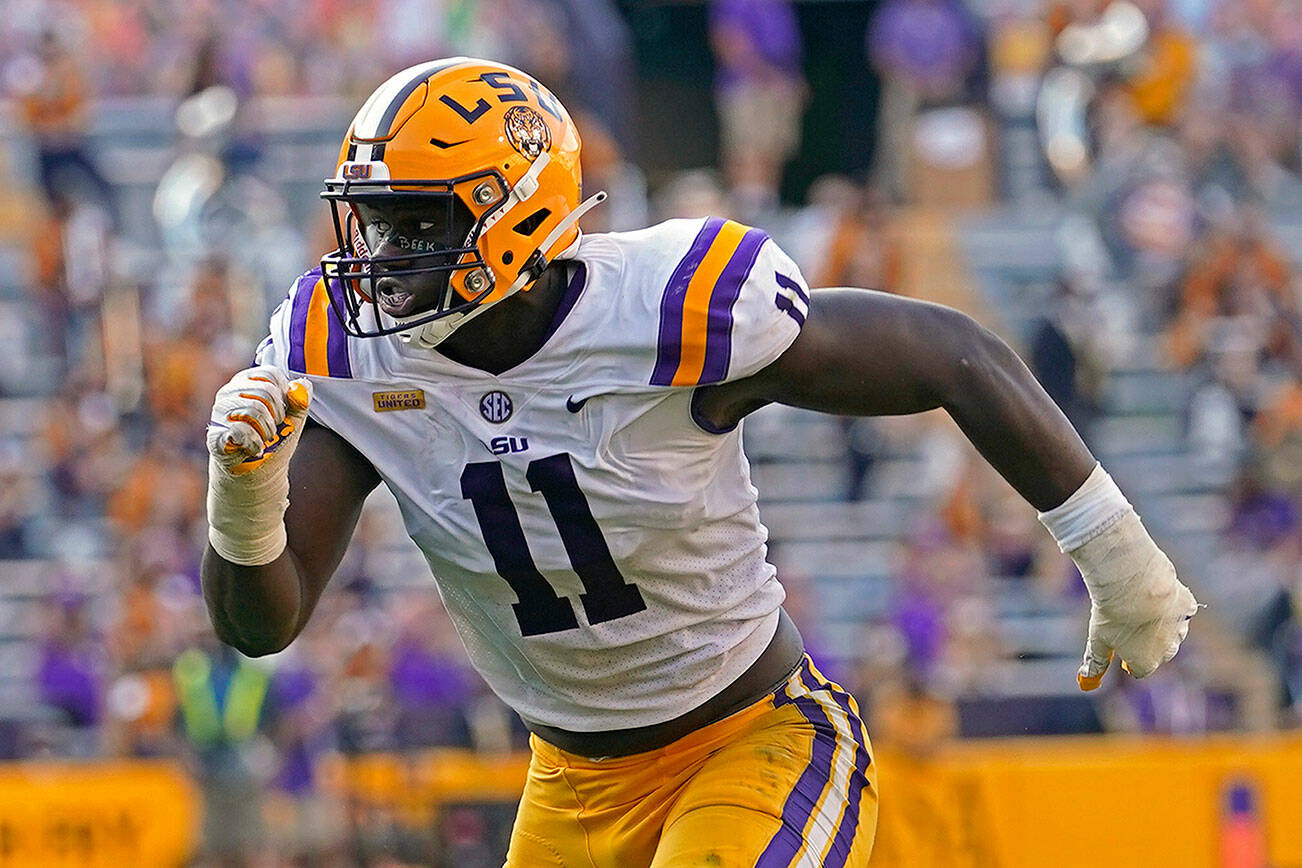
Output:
(634, 217), (809, 387)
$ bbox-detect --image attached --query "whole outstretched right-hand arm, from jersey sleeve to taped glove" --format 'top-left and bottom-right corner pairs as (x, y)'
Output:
(694, 289), (1197, 688)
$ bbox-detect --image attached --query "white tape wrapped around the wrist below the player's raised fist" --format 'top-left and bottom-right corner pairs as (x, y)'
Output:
(208, 455), (289, 566)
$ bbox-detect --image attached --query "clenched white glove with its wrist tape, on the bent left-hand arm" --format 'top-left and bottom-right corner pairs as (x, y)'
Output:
(207, 366), (312, 566)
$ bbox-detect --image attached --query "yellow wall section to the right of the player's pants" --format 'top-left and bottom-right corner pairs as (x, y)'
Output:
(872, 737), (1302, 868)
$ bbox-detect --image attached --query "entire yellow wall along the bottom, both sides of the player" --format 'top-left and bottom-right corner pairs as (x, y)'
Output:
(0, 735), (1302, 868)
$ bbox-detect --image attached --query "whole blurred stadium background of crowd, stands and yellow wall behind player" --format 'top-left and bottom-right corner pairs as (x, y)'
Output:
(0, 0), (1302, 868)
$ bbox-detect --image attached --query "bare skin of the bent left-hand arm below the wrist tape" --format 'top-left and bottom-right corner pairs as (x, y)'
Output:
(201, 423), (380, 657)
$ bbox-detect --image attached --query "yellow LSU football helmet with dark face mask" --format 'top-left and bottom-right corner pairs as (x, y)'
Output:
(322, 57), (605, 346)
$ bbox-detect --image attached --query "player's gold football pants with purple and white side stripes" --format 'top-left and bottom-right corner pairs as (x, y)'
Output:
(506, 656), (878, 868)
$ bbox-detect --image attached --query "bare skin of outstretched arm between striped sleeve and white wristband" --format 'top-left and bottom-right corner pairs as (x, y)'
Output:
(695, 289), (1095, 511)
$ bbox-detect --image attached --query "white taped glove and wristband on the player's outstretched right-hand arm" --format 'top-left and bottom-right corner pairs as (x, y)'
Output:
(1040, 466), (1198, 690)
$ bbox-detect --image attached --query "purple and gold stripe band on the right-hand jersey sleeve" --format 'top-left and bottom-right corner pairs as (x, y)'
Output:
(651, 217), (768, 385)
